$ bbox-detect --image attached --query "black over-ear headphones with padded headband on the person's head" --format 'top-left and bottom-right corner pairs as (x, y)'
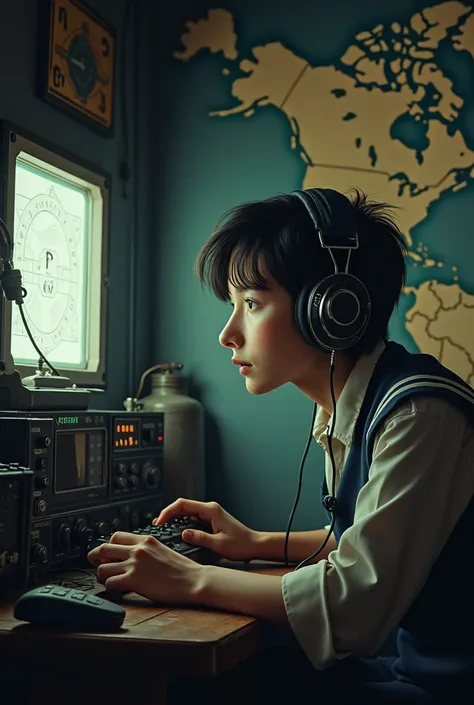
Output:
(292, 189), (371, 352)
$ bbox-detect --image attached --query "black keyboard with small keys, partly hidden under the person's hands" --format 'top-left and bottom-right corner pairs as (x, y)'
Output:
(89, 517), (217, 562)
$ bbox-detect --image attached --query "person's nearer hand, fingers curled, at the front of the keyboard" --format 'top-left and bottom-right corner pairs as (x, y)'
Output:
(87, 531), (203, 604)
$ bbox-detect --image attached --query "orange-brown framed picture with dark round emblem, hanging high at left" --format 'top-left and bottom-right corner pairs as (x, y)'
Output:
(38, 0), (116, 136)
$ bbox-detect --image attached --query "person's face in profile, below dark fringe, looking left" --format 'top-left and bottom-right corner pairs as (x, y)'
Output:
(219, 282), (327, 394)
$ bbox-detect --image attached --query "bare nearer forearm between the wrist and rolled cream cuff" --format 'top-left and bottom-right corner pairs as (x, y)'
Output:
(191, 565), (289, 625)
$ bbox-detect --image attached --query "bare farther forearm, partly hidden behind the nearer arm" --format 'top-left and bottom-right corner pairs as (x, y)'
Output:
(254, 529), (336, 563)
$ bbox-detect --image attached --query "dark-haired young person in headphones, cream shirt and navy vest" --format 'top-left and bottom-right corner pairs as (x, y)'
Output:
(89, 189), (474, 705)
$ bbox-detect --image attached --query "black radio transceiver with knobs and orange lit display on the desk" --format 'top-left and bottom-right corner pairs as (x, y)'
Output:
(0, 410), (164, 582)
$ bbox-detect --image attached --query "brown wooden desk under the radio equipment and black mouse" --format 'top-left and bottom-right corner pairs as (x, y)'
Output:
(0, 564), (286, 705)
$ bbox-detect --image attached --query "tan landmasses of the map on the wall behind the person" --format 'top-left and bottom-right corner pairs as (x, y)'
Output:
(174, 1), (474, 385)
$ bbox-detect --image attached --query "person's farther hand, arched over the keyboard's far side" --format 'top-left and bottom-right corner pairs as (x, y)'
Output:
(152, 499), (258, 561)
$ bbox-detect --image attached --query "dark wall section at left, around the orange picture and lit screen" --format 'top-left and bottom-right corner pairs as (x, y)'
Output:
(0, 0), (151, 409)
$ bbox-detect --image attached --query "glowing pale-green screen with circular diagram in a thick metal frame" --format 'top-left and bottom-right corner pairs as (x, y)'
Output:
(0, 123), (110, 388)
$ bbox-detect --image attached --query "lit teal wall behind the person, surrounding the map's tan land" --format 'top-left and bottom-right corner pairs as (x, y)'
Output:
(150, 0), (474, 529)
